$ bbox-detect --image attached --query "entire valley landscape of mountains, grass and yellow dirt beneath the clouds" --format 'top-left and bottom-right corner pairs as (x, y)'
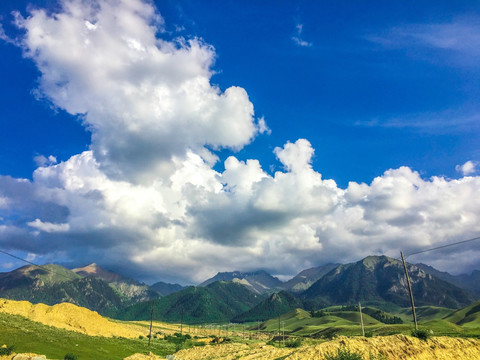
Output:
(0, 256), (480, 359)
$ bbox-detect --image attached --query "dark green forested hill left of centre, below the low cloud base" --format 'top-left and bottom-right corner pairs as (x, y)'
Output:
(117, 281), (263, 324)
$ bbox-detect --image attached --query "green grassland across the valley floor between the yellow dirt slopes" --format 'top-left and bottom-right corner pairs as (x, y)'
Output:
(0, 296), (480, 360)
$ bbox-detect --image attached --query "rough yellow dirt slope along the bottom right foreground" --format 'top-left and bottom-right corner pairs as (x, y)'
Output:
(175, 335), (480, 360)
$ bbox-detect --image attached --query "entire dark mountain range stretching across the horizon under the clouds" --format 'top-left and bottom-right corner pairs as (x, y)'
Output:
(0, 256), (480, 323)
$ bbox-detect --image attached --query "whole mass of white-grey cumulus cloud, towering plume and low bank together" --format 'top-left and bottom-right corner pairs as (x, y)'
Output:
(0, 0), (480, 282)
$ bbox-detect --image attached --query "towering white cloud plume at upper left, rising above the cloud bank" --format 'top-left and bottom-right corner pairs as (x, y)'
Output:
(17, 0), (258, 182)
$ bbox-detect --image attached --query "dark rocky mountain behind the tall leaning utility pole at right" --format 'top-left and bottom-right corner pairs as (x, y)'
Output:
(303, 256), (474, 308)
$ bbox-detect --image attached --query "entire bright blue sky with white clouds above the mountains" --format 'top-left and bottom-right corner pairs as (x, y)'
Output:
(0, 0), (480, 284)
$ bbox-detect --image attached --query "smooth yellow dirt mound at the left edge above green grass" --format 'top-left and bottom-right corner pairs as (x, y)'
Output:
(0, 299), (145, 338)
